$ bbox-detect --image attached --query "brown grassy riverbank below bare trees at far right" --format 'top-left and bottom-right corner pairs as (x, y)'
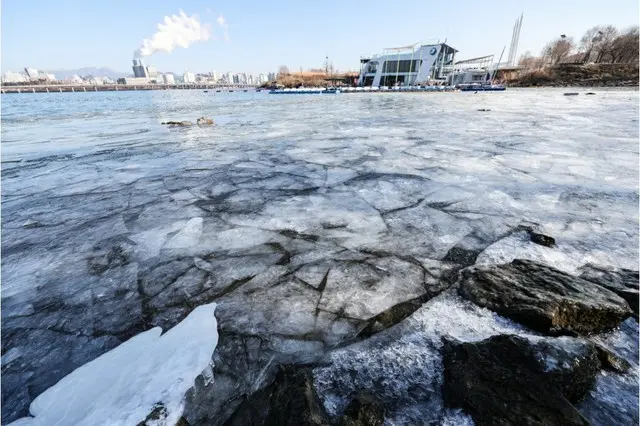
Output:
(505, 64), (639, 87)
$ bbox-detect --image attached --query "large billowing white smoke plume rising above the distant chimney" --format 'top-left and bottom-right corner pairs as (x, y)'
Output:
(133, 10), (212, 58)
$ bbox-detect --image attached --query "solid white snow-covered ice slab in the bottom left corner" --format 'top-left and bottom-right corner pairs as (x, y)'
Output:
(12, 303), (218, 426)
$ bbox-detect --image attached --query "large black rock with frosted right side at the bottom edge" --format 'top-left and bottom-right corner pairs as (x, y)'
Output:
(443, 335), (600, 425)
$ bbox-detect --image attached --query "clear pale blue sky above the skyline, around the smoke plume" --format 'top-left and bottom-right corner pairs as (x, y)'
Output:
(1, 0), (639, 73)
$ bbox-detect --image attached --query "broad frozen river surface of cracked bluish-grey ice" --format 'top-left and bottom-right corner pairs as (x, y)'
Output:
(2, 89), (639, 421)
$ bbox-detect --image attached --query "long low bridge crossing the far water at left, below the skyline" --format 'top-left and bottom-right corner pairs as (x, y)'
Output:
(0, 83), (257, 94)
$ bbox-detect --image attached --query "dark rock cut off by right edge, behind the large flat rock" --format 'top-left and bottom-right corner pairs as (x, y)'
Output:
(579, 263), (640, 317)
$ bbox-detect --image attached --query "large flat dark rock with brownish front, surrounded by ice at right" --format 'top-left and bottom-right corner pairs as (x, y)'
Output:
(458, 259), (632, 334)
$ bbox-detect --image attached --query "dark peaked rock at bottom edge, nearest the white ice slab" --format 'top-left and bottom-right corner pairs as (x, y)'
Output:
(225, 366), (329, 426)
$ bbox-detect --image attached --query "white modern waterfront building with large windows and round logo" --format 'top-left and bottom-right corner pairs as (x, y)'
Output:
(358, 43), (457, 87)
